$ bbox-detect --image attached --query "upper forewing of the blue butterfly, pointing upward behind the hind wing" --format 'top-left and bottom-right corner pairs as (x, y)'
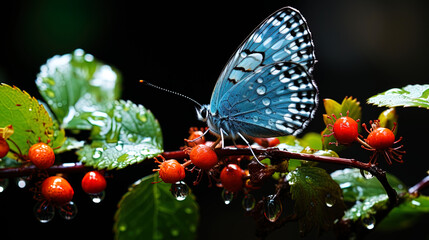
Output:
(210, 7), (316, 113)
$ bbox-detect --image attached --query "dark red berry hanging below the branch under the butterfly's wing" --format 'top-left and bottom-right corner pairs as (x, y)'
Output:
(220, 164), (244, 192)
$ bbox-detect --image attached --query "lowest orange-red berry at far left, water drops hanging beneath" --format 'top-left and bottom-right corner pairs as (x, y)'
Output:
(42, 176), (74, 205)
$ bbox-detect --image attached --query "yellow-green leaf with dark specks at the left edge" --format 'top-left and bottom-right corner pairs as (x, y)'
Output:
(0, 84), (65, 160)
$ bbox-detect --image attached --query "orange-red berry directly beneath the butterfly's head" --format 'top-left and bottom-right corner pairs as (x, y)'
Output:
(189, 144), (218, 170)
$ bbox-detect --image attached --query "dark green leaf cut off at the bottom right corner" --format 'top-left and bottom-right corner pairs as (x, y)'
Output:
(377, 195), (429, 231)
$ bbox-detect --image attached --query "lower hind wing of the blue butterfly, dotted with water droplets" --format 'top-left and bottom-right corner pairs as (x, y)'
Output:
(218, 62), (318, 138)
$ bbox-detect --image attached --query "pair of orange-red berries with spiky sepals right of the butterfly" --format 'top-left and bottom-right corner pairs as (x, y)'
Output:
(324, 112), (405, 165)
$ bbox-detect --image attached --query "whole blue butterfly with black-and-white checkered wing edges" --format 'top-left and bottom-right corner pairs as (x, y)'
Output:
(197, 7), (318, 146)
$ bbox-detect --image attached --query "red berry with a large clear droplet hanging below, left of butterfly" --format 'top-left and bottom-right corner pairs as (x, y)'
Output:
(155, 159), (185, 183)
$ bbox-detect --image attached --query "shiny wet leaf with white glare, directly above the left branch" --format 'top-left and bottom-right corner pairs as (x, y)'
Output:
(78, 100), (163, 169)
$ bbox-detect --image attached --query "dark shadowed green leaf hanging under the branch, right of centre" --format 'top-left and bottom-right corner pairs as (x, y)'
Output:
(286, 167), (345, 233)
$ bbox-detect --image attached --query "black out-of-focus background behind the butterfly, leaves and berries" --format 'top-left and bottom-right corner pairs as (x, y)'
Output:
(0, 0), (429, 239)
